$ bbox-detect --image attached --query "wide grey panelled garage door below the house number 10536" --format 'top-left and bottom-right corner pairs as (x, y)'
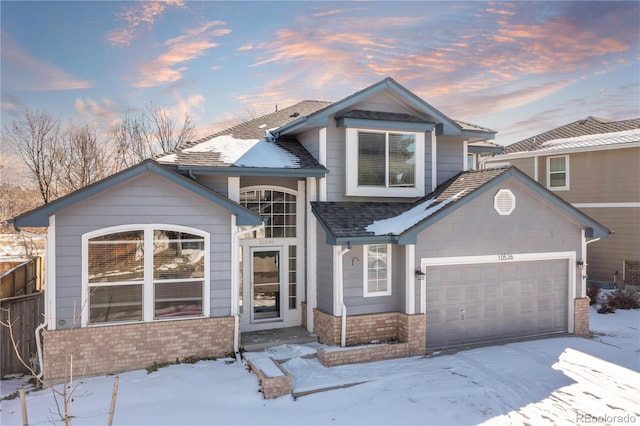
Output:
(426, 259), (569, 349)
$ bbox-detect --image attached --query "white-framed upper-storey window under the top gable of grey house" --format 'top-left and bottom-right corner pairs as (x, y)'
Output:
(346, 128), (424, 197)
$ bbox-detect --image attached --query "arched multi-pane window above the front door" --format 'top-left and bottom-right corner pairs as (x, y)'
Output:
(240, 188), (296, 238)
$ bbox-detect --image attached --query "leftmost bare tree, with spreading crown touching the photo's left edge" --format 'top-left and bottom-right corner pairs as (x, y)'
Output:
(3, 110), (60, 203)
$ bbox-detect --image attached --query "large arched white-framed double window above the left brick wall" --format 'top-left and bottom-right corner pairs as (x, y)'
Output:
(82, 225), (209, 325)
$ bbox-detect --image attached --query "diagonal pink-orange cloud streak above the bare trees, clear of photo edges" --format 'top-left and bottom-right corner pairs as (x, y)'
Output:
(133, 21), (231, 88)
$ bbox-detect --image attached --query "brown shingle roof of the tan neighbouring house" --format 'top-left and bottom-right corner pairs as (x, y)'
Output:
(504, 116), (640, 154)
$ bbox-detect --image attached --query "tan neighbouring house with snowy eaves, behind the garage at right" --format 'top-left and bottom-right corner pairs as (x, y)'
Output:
(484, 117), (640, 286)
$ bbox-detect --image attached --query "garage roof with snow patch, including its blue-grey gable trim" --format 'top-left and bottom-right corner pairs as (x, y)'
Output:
(312, 167), (610, 245)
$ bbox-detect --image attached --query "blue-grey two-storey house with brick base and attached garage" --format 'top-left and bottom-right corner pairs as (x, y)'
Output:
(13, 78), (609, 377)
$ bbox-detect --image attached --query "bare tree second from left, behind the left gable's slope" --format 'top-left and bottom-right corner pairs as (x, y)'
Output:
(56, 123), (110, 193)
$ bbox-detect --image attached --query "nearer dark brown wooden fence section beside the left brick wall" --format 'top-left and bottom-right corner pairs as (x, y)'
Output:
(0, 291), (44, 378)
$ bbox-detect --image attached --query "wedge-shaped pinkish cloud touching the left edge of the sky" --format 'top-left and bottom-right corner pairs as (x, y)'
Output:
(0, 31), (93, 91)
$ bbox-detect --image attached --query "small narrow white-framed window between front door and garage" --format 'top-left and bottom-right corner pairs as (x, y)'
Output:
(364, 244), (391, 297)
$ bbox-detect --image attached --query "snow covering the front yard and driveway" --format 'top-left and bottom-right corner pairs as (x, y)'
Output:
(0, 308), (640, 426)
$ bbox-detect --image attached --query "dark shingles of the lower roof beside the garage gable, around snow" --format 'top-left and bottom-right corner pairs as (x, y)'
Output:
(311, 167), (509, 238)
